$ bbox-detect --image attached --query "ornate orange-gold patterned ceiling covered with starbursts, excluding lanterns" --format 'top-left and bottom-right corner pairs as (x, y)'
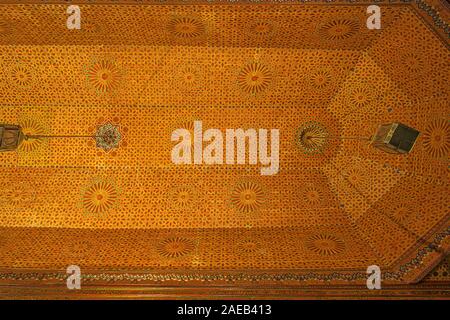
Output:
(0, 0), (450, 297)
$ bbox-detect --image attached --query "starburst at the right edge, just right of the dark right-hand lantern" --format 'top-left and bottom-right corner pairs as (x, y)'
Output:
(423, 119), (450, 158)
